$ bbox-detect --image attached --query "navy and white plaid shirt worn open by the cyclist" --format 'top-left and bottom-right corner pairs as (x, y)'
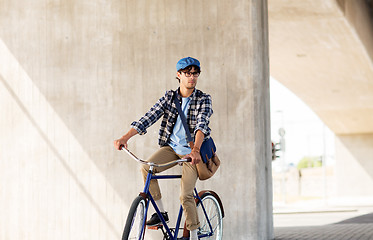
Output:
(131, 89), (213, 146)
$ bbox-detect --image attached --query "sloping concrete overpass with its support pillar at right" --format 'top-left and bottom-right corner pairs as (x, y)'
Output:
(268, 0), (373, 196)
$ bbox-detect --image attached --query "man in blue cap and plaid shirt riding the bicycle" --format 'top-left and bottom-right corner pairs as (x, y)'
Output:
(114, 57), (213, 240)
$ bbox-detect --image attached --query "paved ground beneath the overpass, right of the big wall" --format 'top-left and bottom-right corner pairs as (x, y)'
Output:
(274, 198), (373, 240)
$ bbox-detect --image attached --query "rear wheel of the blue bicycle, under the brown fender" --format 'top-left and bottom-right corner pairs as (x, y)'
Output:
(197, 192), (224, 240)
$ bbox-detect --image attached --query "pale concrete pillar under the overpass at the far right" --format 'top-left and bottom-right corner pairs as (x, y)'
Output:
(336, 134), (373, 197)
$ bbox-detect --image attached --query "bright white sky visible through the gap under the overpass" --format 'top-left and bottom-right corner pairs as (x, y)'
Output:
(270, 77), (334, 170)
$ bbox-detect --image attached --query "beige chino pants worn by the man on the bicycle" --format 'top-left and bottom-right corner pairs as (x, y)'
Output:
(141, 146), (199, 230)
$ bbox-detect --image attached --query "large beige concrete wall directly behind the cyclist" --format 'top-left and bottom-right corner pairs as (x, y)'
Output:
(0, 0), (272, 239)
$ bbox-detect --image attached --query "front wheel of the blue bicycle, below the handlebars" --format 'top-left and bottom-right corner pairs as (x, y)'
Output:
(122, 196), (146, 240)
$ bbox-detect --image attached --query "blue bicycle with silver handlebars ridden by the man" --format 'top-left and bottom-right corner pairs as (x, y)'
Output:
(122, 148), (224, 240)
